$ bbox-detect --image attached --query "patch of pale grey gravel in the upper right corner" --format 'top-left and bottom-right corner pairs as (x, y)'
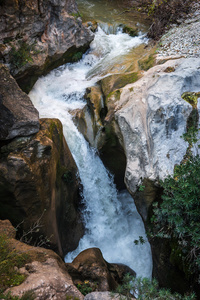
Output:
(157, 4), (200, 58)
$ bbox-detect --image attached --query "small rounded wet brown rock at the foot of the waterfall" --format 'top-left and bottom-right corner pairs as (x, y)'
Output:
(66, 248), (135, 291)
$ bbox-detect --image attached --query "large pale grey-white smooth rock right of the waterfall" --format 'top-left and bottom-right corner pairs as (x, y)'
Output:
(115, 59), (200, 219)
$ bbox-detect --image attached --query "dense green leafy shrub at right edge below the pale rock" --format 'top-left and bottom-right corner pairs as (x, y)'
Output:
(152, 155), (200, 280)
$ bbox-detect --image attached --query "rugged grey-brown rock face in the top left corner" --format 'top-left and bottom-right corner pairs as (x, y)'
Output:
(0, 0), (93, 92)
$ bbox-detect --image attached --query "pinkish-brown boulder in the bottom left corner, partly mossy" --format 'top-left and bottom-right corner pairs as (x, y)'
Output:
(0, 220), (84, 300)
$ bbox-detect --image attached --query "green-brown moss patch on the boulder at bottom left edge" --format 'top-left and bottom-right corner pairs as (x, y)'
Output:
(0, 235), (30, 290)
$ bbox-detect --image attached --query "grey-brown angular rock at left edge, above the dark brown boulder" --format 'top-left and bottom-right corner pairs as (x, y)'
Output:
(0, 65), (39, 140)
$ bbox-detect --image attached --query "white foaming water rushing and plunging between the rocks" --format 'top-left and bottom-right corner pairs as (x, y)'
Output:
(29, 24), (152, 277)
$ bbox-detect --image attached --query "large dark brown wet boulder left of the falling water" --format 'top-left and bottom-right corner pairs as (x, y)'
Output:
(0, 119), (83, 255)
